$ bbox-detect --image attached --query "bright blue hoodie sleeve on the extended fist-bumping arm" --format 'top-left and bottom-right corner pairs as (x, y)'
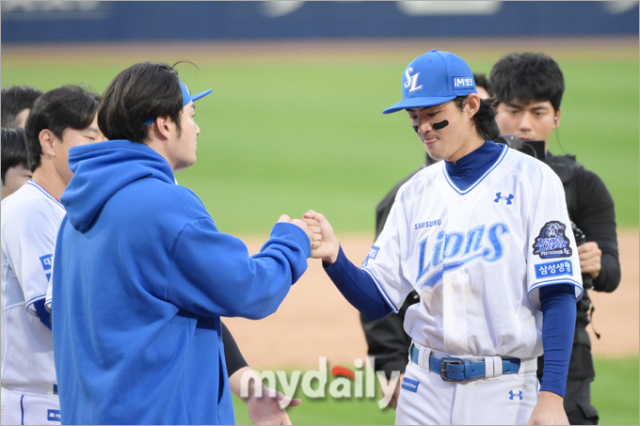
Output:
(166, 218), (311, 319)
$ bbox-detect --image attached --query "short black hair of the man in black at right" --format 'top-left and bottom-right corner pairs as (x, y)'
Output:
(490, 52), (564, 111)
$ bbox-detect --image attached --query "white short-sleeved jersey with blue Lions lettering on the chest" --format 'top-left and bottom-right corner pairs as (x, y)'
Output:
(362, 146), (582, 359)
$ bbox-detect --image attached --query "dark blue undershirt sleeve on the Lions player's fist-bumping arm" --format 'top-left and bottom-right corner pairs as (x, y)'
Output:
(323, 246), (393, 321)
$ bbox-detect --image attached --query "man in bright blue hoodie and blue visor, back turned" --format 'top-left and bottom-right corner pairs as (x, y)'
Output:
(52, 62), (311, 424)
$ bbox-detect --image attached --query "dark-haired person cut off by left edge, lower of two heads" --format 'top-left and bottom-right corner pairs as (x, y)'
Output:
(0, 127), (31, 200)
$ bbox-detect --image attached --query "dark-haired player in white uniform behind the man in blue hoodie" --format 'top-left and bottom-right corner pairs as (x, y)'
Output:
(1, 86), (104, 425)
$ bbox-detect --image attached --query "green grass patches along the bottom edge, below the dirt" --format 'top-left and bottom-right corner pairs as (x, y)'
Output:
(234, 358), (639, 425)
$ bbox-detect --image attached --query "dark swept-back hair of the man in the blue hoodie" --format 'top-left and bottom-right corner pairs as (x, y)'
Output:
(98, 62), (182, 143)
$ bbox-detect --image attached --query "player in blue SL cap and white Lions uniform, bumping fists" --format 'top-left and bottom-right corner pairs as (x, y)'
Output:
(304, 50), (582, 424)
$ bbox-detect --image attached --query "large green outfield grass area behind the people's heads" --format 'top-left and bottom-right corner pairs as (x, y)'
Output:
(2, 41), (639, 234)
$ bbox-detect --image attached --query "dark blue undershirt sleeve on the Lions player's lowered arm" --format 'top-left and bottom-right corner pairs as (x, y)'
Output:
(540, 284), (576, 397)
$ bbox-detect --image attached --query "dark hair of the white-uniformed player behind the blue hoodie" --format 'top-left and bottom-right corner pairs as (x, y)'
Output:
(25, 85), (100, 172)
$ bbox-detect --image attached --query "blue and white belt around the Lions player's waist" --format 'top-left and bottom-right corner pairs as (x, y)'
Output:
(410, 343), (521, 382)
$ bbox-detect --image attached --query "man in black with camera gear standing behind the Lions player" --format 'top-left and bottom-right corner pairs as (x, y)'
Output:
(490, 52), (620, 425)
